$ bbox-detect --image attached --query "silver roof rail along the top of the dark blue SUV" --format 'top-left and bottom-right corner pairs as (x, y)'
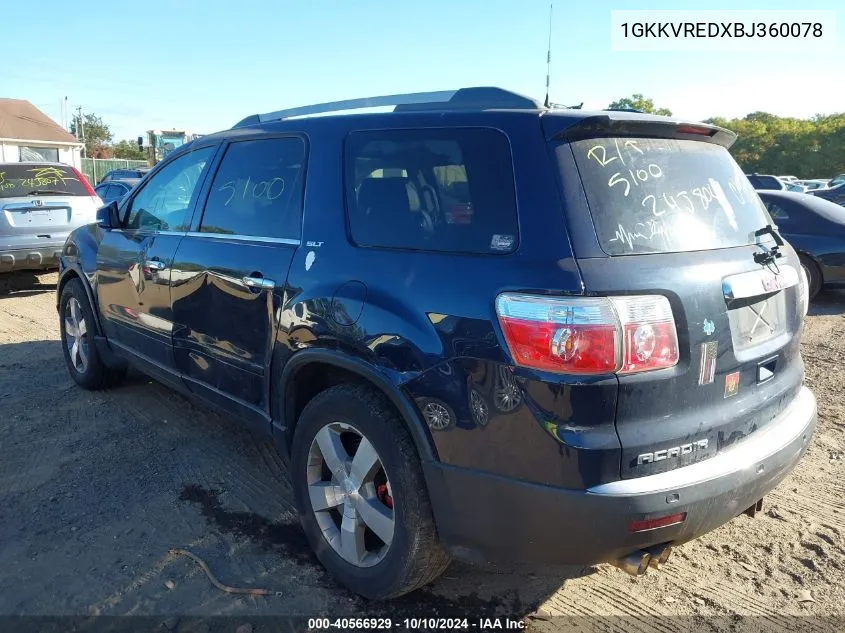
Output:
(235, 87), (545, 127)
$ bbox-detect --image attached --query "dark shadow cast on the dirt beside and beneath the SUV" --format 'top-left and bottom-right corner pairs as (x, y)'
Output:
(0, 341), (580, 621)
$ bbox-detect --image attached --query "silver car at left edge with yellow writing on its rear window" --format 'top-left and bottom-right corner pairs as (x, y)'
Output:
(0, 162), (103, 272)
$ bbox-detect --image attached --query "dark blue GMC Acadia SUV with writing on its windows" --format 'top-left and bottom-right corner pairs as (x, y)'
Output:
(57, 88), (816, 598)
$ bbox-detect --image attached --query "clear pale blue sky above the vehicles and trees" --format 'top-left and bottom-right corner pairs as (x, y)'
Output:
(0, 0), (845, 140)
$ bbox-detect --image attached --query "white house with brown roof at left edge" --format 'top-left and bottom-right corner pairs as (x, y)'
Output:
(0, 99), (82, 169)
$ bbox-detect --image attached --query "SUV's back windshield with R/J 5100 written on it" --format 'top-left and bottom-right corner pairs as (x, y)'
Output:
(558, 138), (769, 255)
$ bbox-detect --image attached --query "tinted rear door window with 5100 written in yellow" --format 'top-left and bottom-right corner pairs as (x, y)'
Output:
(199, 137), (305, 239)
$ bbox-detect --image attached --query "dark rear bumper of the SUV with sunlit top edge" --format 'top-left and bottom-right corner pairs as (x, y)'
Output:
(424, 387), (817, 565)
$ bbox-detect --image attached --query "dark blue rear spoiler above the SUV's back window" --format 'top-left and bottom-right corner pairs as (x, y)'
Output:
(542, 112), (736, 147)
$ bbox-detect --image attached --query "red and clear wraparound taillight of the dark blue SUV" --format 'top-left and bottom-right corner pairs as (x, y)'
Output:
(496, 293), (678, 374)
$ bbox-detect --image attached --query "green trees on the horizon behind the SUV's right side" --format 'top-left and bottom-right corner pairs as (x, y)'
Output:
(608, 94), (845, 178)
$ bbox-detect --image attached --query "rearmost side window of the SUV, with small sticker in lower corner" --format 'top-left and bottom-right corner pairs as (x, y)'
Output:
(345, 128), (518, 254)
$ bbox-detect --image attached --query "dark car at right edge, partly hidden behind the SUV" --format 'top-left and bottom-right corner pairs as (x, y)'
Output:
(757, 191), (845, 299)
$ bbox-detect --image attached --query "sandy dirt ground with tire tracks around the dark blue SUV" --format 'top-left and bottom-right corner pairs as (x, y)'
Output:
(0, 292), (845, 633)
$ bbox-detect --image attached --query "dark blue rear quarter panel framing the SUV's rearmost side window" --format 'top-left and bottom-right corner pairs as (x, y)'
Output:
(276, 113), (619, 487)
